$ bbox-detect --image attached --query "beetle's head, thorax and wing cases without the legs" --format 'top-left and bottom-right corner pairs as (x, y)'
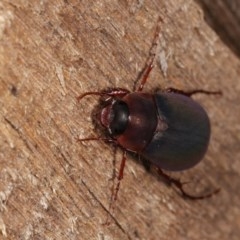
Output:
(100, 90), (210, 171)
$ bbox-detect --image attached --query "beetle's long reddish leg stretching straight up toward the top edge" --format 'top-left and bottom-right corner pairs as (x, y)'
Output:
(134, 17), (163, 92)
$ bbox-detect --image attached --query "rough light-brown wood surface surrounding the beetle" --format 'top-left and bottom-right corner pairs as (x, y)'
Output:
(0, 0), (240, 240)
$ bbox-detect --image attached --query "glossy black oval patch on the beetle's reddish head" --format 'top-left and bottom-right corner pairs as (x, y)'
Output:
(110, 101), (129, 136)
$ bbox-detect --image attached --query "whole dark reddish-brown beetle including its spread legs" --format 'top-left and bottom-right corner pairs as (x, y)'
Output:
(78, 19), (221, 212)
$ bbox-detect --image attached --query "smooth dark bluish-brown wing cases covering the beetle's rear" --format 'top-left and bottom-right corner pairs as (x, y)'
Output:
(142, 93), (210, 171)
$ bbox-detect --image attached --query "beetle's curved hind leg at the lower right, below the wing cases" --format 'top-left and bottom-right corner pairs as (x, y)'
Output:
(157, 168), (220, 200)
